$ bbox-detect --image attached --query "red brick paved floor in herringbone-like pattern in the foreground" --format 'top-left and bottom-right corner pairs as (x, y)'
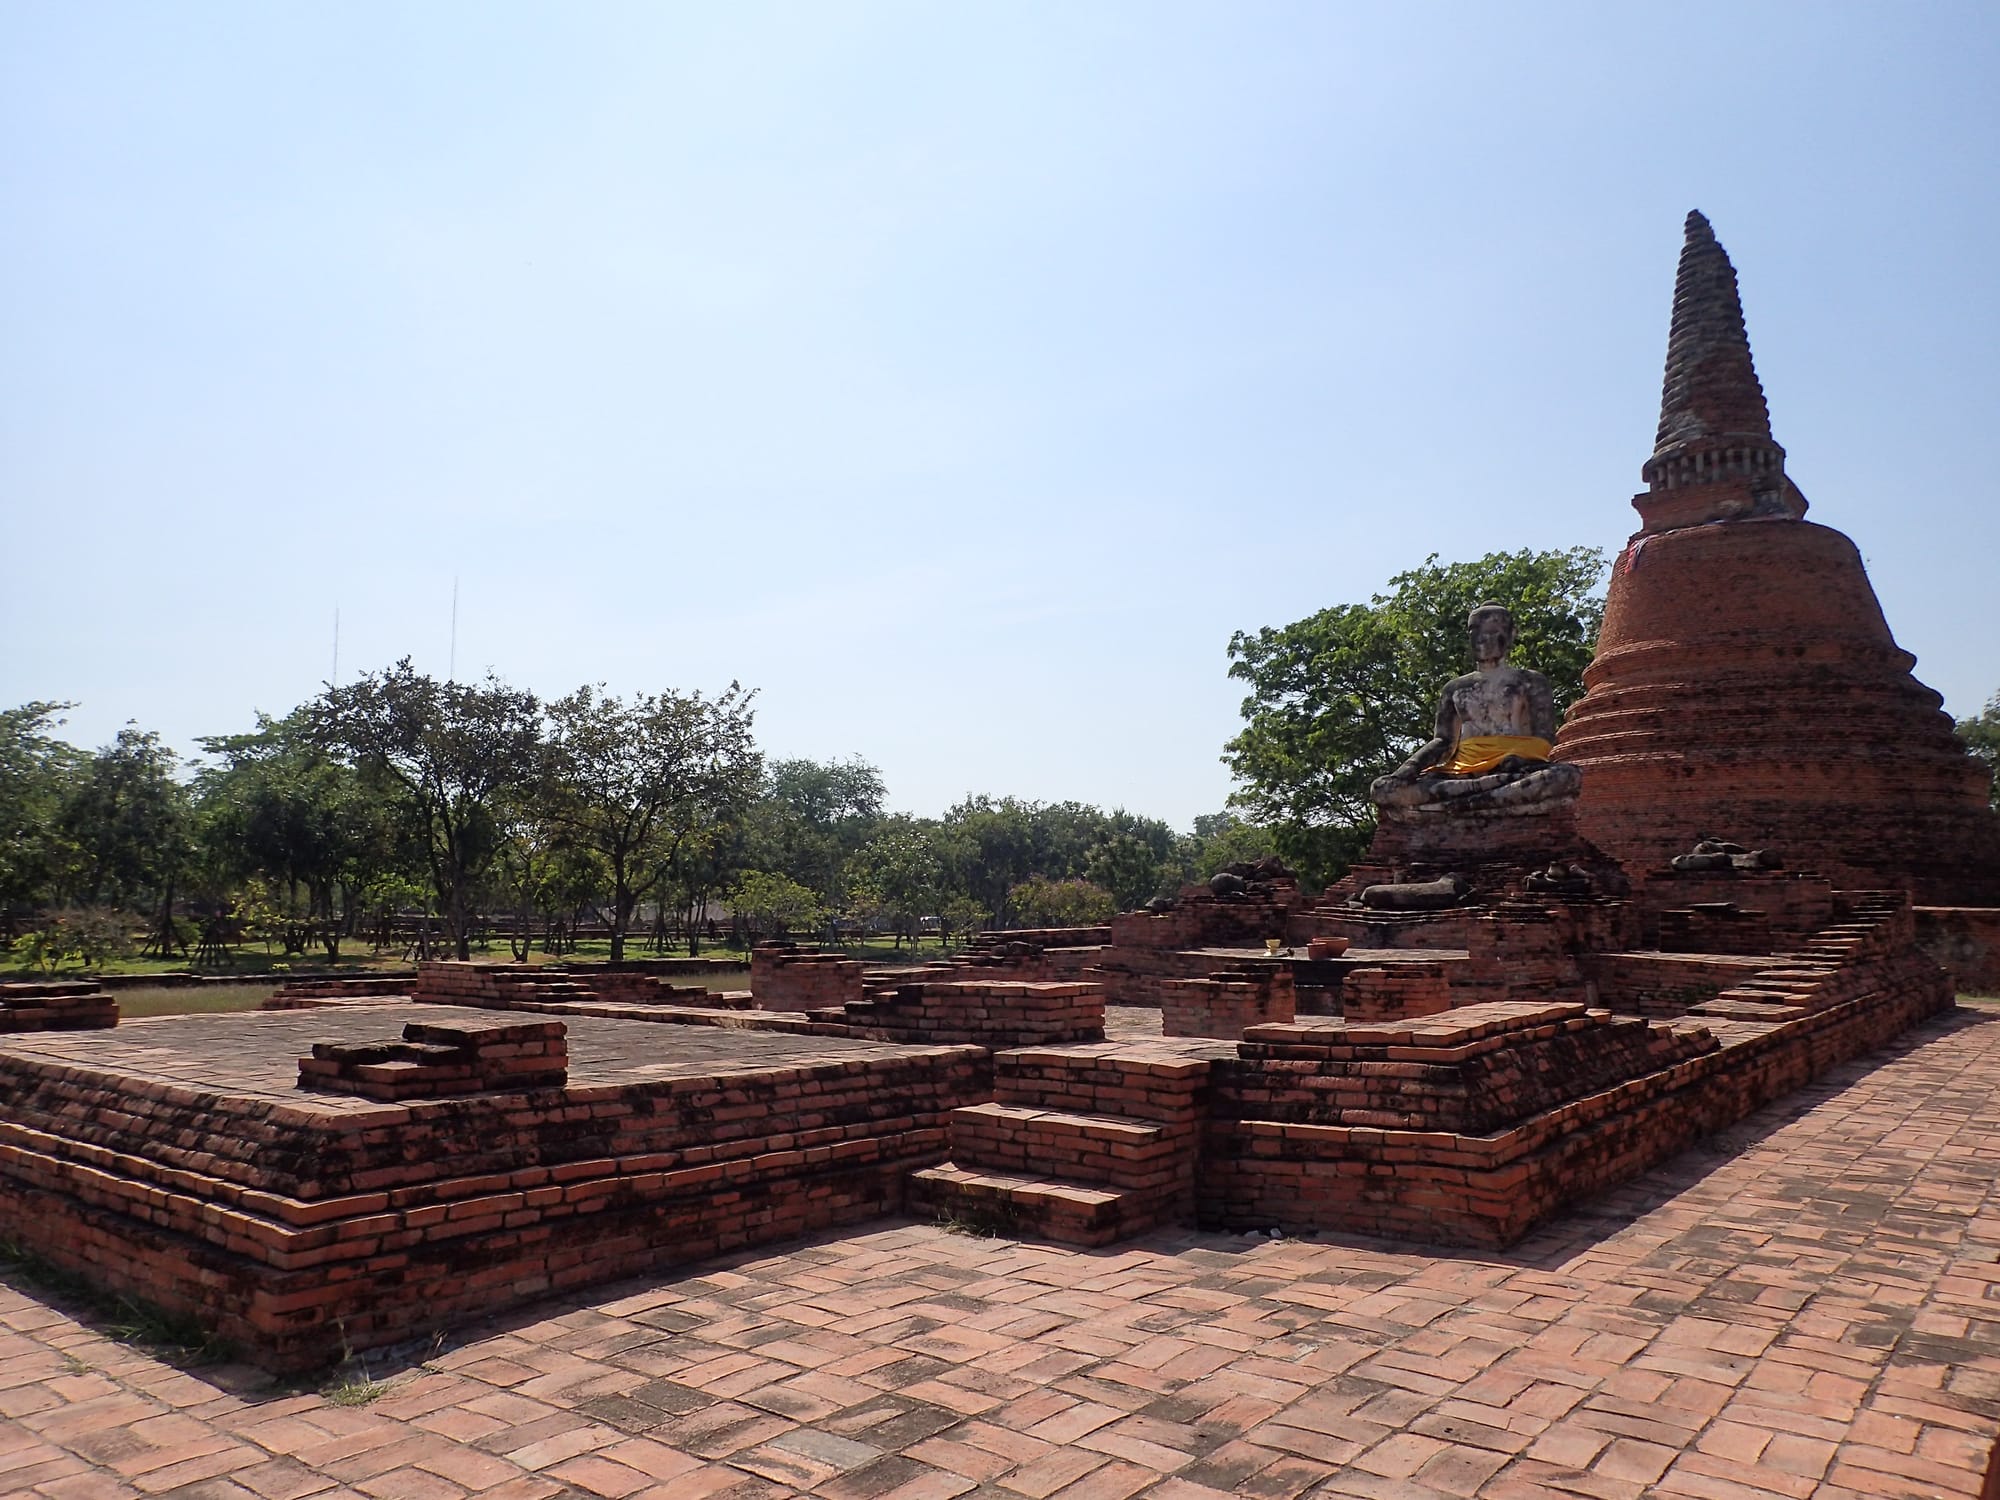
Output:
(0, 1010), (2000, 1500)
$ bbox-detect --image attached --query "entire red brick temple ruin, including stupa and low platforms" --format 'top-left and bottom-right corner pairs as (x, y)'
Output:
(0, 216), (1994, 1370)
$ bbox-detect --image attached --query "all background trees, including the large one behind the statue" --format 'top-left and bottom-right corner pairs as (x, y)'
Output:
(19, 548), (2000, 976)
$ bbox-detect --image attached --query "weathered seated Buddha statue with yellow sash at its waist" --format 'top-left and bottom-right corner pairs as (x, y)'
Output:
(1368, 604), (1582, 816)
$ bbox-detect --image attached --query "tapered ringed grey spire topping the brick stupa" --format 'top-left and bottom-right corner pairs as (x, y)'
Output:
(1640, 210), (1806, 530)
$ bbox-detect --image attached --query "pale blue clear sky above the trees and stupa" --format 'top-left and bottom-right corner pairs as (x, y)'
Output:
(0, 0), (2000, 826)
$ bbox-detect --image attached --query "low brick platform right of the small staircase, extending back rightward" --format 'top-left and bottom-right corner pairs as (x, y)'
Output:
(1200, 960), (1950, 1246)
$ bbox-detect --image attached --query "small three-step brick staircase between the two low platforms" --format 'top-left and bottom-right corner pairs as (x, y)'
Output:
(910, 1040), (1236, 1246)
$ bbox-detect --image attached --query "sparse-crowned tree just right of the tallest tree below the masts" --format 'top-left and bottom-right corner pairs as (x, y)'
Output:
(548, 682), (762, 964)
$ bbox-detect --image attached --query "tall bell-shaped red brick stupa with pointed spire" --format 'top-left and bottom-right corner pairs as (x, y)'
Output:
(1554, 214), (2000, 904)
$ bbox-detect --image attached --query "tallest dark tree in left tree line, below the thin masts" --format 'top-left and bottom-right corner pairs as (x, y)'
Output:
(304, 656), (542, 958)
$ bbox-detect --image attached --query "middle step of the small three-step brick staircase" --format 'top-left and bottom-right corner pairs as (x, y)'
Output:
(950, 1104), (1176, 1190)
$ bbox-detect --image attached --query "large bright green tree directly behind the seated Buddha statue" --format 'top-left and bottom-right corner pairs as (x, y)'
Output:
(1222, 548), (1604, 882)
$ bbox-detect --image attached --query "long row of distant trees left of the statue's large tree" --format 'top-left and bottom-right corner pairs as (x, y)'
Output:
(0, 660), (1274, 966)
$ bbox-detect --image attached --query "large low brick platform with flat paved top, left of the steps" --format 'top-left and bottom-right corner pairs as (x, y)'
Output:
(0, 1004), (990, 1368)
